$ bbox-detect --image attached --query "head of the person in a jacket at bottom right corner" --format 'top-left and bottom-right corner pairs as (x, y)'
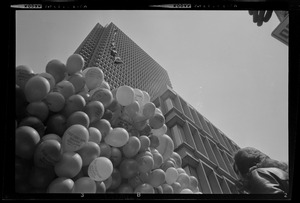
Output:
(233, 147), (288, 179)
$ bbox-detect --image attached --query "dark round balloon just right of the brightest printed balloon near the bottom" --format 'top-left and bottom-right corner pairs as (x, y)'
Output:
(119, 158), (138, 179)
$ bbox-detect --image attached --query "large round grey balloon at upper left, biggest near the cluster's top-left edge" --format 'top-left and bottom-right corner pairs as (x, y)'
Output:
(24, 75), (50, 102)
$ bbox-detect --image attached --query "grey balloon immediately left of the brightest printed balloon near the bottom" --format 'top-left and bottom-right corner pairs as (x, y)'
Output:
(54, 152), (82, 178)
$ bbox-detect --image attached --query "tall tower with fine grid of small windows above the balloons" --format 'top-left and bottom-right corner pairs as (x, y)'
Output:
(75, 23), (172, 98)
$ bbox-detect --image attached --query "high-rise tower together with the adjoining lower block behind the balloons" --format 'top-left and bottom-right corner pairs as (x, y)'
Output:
(75, 23), (239, 194)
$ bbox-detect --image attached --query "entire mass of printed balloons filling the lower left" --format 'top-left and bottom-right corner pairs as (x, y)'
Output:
(15, 54), (201, 193)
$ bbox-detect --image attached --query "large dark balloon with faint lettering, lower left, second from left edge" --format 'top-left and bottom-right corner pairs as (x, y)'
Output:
(34, 140), (62, 168)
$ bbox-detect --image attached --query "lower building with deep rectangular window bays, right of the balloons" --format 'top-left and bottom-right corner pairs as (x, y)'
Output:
(153, 87), (240, 194)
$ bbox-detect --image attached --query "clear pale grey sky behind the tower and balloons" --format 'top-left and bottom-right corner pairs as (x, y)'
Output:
(16, 10), (289, 162)
